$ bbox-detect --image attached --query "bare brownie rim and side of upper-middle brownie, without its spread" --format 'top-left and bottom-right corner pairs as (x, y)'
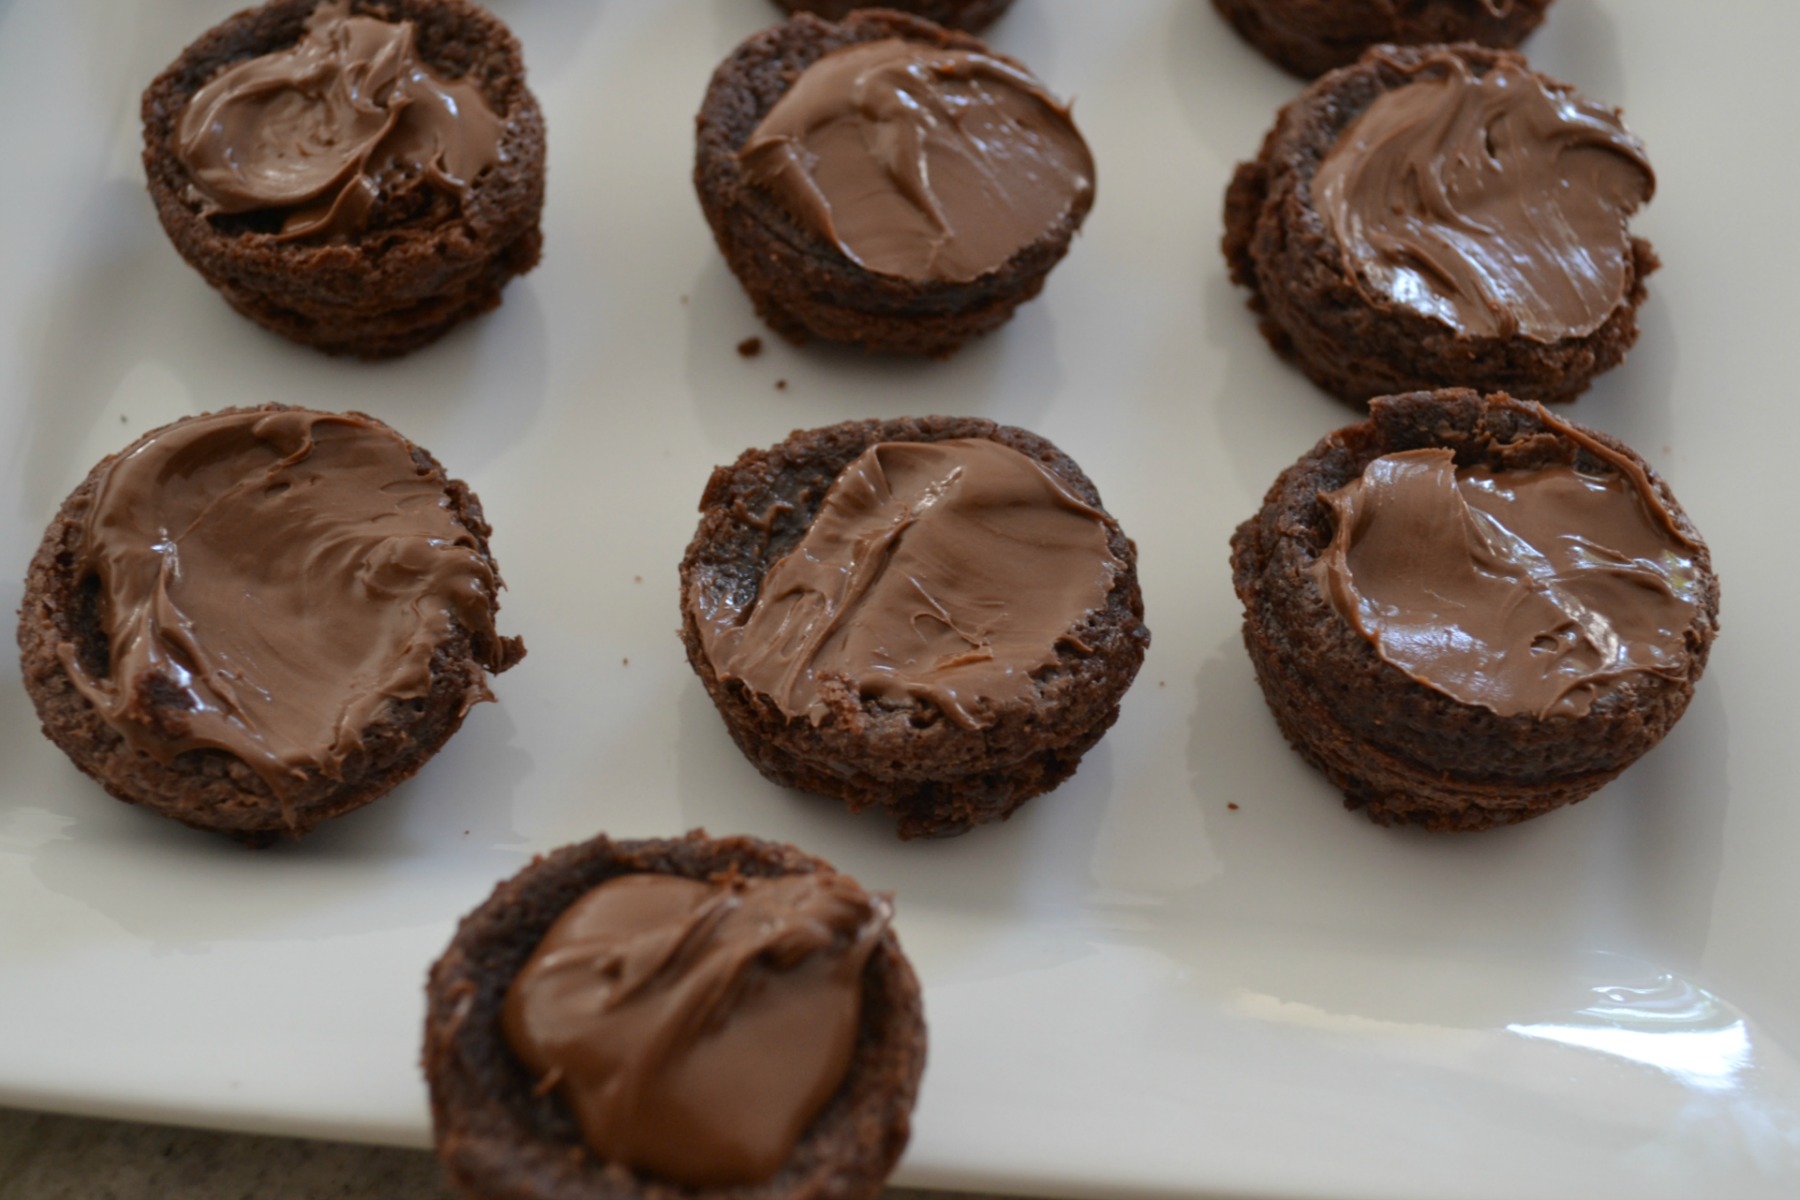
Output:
(693, 9), (1093, 358)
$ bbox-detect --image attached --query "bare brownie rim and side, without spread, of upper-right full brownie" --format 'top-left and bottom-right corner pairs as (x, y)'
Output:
(1222, 45), (1660, 407)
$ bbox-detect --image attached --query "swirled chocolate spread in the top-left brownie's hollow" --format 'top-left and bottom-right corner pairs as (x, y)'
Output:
(175, 0), (504, 239)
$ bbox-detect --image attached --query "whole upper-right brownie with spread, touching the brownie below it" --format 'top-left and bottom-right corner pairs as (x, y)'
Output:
(1224, 45), (1658, 405)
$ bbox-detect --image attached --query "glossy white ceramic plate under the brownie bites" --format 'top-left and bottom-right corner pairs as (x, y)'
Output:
(0, 0), (1800, 1200)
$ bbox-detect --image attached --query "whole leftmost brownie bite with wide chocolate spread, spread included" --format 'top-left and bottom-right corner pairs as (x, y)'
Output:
(18, 407), (524, 846)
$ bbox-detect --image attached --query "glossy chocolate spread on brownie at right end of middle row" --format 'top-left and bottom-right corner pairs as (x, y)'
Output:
(1312, 423), (1705, 718)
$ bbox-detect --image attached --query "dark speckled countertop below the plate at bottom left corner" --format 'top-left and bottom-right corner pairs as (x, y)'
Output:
(0, 1108), (976, 1200)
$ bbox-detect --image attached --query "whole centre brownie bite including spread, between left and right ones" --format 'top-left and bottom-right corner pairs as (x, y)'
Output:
(680, 417), (1150, 838)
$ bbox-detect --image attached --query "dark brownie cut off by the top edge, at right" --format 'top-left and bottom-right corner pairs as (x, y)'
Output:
(1213, 0), (1550, 79)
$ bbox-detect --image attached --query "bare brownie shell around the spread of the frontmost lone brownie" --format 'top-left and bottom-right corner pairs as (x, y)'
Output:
(423, 831), (925, 1200)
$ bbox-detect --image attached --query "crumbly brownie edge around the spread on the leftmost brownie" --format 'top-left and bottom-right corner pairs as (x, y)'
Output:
(18, 405), (524, 846)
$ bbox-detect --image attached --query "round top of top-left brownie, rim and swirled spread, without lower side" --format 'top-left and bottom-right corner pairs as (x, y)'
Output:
(142, 0), (544, 244)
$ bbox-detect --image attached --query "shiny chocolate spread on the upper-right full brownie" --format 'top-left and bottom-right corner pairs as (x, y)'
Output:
(1312, 52), (1656, 342)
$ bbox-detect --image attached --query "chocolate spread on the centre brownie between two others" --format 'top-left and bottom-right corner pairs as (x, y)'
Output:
(695, 439), (1123, 729)
